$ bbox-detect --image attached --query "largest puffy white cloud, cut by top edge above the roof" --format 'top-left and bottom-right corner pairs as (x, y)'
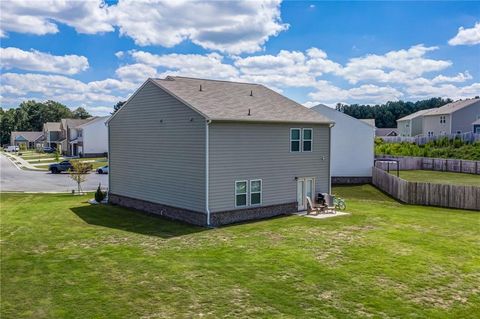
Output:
(111, 0), (288, 54)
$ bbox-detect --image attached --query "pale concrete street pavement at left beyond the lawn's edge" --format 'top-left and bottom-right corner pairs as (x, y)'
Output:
(0, 154), (108, 192)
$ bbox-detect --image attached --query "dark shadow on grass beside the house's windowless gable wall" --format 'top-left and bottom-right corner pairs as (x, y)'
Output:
(70, 205), (207, 239)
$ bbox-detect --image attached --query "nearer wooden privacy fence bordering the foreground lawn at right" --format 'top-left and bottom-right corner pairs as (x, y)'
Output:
(372, 167), (480, 211)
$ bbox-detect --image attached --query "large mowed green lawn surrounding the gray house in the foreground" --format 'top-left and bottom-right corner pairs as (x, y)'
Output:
(0, 186), (480, 318)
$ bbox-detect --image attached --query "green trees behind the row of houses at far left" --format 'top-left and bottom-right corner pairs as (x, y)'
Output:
(0, 100), (91, 145)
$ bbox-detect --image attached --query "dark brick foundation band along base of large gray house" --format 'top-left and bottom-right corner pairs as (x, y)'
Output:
(108, 193), (297, 227)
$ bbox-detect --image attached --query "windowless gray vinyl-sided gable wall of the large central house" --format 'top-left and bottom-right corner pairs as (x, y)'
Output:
(109, 83), (206, 212)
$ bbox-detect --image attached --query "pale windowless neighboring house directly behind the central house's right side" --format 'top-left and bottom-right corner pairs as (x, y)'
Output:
(312, 104), (375, 183)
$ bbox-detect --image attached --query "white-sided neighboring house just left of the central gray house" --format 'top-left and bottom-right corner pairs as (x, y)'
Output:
(76, 116), (109, 157)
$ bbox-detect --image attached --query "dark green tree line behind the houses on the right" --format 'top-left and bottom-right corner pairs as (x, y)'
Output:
(336, 97), (452, 128)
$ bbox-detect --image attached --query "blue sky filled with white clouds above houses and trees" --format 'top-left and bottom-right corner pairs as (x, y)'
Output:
(0, 0), (480, 115)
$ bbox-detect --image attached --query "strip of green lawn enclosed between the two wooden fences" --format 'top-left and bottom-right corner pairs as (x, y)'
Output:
(390, 170), (480, 186)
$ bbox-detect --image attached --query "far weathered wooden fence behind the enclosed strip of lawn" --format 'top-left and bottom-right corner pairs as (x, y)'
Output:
(376, 155), (480, 174)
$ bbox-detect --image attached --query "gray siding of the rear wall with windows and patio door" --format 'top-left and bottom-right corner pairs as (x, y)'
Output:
(209, 122), (330, 212)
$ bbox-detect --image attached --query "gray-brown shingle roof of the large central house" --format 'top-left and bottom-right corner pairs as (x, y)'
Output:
(152, 76), (333, 123)
